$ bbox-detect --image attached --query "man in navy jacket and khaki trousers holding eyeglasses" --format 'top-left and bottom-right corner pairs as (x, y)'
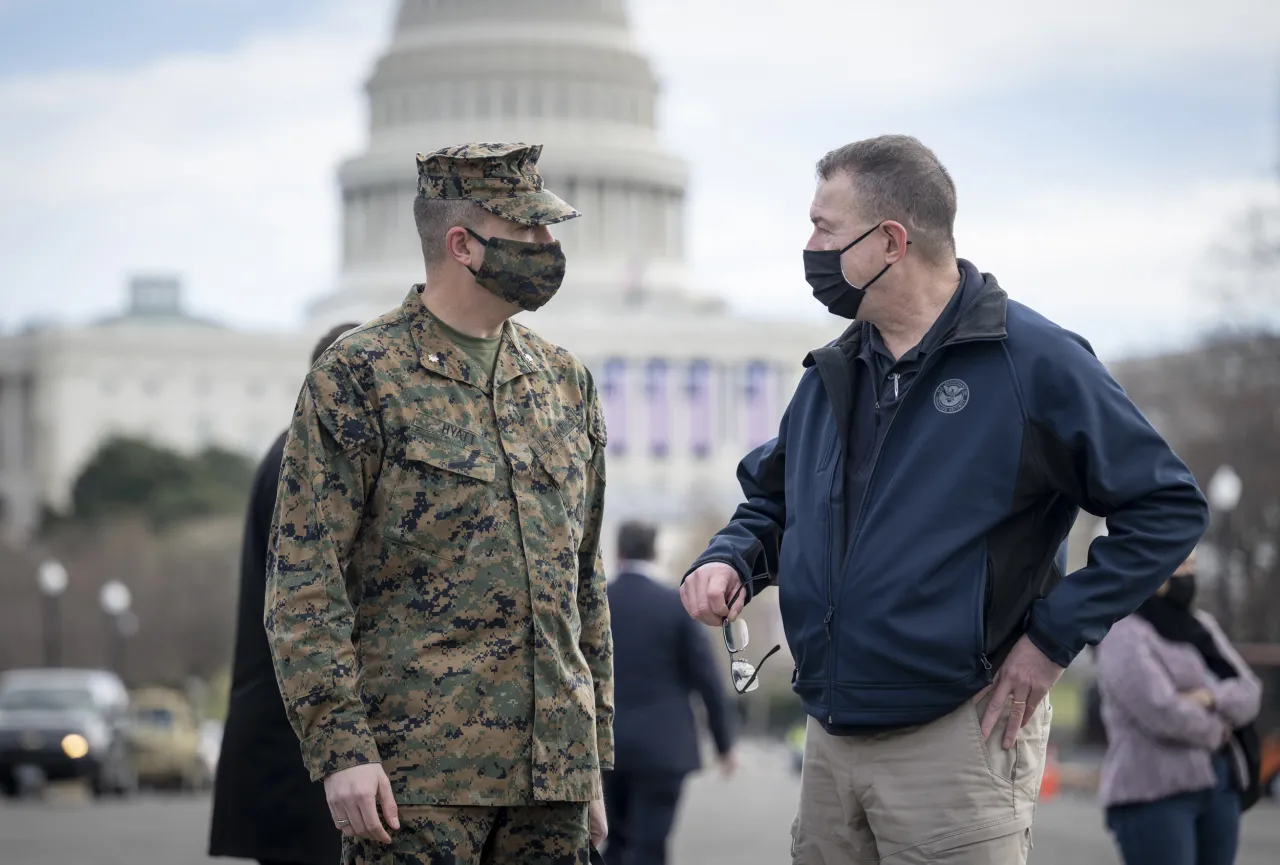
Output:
(681, 136), (1208, 865)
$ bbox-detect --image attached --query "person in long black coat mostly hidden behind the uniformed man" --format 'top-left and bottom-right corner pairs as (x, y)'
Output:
(209, 324), (357, 865)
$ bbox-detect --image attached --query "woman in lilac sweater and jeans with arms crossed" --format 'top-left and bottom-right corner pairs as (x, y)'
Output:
(1098, 554), (1262, 865)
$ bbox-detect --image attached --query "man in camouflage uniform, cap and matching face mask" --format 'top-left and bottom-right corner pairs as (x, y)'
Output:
(266, 145), (613, 865)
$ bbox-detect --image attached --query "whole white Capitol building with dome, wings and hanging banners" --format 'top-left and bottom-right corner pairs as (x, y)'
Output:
(0, 0), (844, 560)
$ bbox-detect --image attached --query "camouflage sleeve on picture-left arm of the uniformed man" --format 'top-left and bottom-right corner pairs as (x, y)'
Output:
(265, 358), (381, 781)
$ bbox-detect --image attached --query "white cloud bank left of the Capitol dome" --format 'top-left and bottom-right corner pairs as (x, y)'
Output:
(0, 0), (387, 324)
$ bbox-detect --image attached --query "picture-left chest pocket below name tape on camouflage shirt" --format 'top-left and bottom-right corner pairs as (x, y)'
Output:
(384, 438), (498, 562)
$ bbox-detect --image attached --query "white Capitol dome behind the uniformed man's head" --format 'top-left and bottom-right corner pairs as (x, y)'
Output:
(311, 0), (686, 322)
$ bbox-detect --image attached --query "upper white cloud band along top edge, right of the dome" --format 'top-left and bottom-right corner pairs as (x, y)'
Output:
(631, 0), (1280, 122)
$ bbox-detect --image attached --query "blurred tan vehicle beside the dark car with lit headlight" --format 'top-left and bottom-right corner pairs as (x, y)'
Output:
(132, 688), (211, 790)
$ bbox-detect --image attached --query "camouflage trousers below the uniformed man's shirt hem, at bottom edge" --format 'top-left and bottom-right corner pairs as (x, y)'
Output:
(342, 802), (590, 865)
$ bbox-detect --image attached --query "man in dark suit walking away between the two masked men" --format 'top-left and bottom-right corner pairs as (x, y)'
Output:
(604, 522), (736, 865)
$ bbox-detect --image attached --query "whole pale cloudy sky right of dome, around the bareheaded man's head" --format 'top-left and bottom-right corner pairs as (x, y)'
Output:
(632, 0), (1280, 356)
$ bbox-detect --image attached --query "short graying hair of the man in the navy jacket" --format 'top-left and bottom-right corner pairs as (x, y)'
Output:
(818, 136), (956, 264)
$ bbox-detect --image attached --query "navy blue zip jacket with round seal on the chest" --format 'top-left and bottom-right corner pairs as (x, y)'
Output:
(694, 261), (1207, 731)
